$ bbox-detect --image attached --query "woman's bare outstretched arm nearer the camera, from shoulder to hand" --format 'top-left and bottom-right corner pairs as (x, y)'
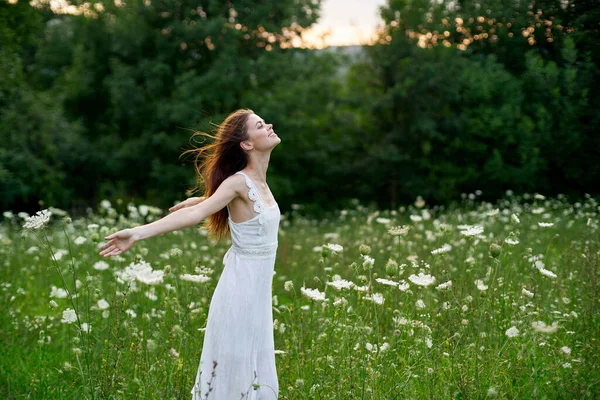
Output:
(99, 177), (243, 257)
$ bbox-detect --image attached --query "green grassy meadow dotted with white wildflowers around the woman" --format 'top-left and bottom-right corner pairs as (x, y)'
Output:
(0, 192), (600, 400)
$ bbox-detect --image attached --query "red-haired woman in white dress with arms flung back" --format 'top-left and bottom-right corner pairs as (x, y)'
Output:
(100, 109), (281, 400)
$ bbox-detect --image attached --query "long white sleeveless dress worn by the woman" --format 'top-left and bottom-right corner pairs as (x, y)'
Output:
(191, 171), (281, 400)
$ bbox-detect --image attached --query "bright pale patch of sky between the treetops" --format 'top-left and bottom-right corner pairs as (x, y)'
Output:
(303, 0), (386, 48)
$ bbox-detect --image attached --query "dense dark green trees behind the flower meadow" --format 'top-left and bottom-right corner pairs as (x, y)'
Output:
(0, 0), (600, 216)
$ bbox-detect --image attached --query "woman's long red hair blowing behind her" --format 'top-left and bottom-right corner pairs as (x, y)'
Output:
(182, 108), (254, 243)
